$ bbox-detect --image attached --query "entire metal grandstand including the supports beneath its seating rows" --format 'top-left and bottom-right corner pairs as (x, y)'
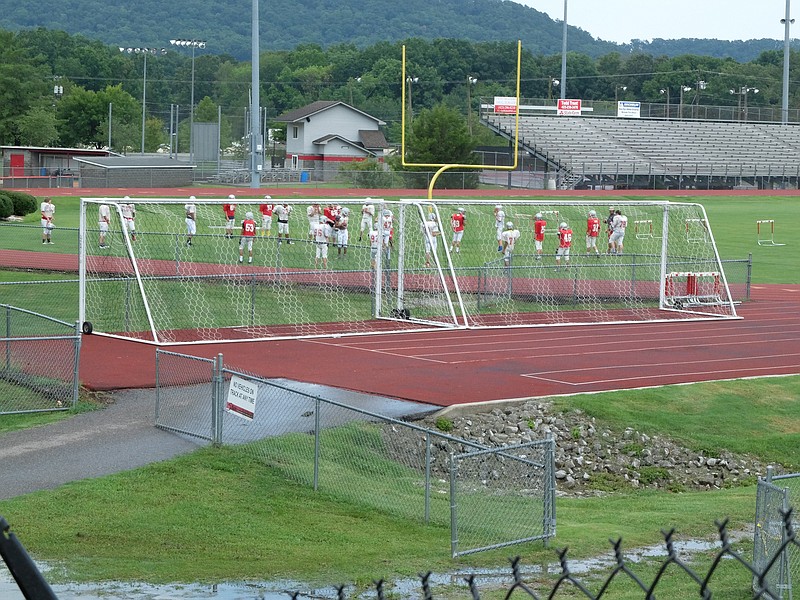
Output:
(481, 101), (800, 190)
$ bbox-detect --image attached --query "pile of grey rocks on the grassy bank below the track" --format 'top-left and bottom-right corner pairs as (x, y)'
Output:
(410, 401), (778, 496)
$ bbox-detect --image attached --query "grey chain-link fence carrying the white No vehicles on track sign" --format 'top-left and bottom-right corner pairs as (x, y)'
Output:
(156, 349), (556, 557)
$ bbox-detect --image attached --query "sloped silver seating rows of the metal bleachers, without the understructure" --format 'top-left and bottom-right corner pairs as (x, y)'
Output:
(484, 115), (800, 185)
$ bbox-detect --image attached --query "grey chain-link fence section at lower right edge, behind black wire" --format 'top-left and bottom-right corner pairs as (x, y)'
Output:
(753, 467), (800, 600)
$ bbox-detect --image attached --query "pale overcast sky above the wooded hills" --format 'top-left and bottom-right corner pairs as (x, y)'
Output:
(514, 0), (800, 43)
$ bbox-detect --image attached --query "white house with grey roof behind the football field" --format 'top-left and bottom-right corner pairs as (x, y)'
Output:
(276, 100), (389, 181)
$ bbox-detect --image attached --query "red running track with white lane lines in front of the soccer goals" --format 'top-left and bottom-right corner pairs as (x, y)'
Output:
(80, 285), (800, 406)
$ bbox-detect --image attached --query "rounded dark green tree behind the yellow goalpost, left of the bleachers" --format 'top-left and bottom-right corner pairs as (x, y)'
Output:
(406, 104), (478, 188)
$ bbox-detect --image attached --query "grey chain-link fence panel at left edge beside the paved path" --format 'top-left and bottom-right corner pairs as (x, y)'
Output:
(0, 304), (81, 414)
